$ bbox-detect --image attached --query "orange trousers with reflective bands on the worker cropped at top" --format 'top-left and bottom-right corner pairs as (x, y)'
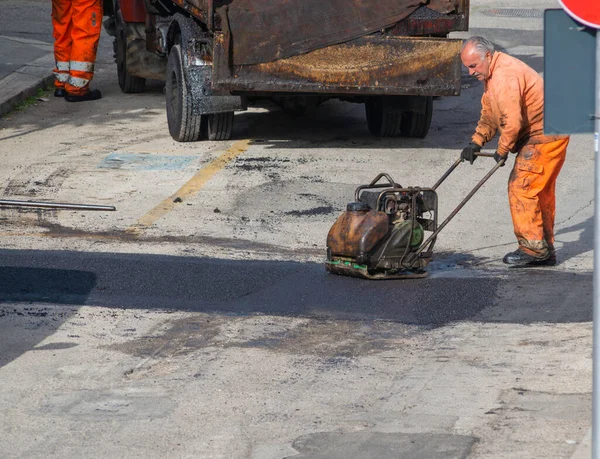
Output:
(52, 0), (102, 95)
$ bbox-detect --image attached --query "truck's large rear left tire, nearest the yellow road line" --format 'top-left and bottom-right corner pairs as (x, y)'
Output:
(165, 45), (203, 142)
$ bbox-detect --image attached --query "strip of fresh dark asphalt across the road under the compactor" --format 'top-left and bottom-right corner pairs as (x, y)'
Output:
(0, 250), (592, 327)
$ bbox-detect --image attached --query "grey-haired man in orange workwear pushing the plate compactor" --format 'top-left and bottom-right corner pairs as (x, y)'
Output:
(460, 37), (569, 267)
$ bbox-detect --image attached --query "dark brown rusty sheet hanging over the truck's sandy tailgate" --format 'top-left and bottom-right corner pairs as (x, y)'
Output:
(215, 0), (427, 65)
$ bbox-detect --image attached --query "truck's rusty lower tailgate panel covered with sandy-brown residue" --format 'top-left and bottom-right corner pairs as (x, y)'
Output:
(213, 36), (462, 96)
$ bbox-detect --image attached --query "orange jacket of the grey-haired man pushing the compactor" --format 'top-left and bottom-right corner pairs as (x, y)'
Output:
(472, 51), (565, 156)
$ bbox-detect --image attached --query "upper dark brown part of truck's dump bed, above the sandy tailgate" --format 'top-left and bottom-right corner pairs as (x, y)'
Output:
(169, 0), (469, 65)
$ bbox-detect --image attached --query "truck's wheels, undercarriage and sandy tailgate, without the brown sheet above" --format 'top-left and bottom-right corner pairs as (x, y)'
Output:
(105, 0), (469, 142)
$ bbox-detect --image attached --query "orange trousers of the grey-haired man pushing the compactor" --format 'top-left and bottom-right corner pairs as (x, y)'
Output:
(508, 137), (569, 258)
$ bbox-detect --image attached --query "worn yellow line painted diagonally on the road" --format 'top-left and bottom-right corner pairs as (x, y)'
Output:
(125, 140), (250, 234)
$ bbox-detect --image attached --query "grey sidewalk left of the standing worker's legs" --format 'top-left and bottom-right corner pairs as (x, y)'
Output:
(0, 35), (54, 116)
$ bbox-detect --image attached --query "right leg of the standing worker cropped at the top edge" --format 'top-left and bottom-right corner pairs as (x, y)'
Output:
(65, 0), (102, 102)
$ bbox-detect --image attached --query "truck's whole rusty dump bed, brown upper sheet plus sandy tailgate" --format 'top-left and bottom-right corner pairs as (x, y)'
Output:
(165, 0), (469, 96)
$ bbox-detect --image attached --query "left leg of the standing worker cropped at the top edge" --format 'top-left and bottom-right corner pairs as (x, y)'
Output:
(52, 0), (73, 97)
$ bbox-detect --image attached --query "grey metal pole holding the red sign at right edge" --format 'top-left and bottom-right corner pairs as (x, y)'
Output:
(592, 30), (600, 459)
